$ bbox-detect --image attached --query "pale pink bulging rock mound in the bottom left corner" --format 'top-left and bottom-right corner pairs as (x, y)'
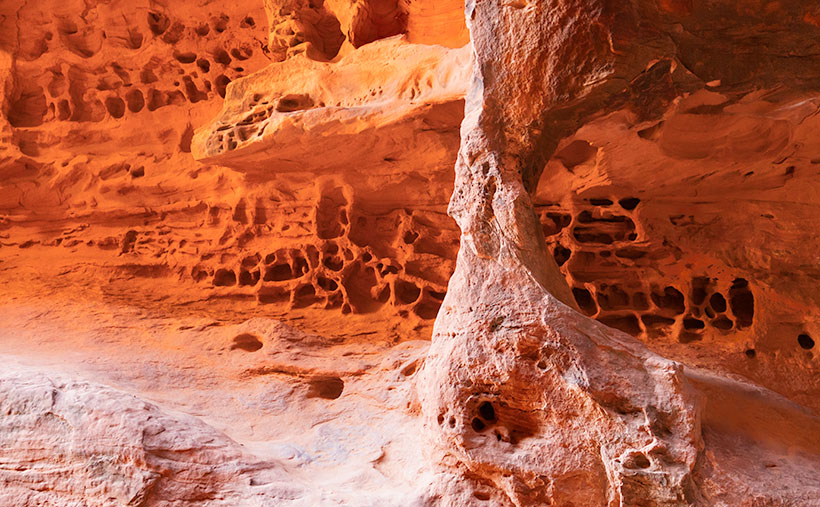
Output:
(0, 364), (250, 505)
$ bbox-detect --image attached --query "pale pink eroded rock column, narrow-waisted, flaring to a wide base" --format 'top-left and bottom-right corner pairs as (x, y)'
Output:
(419, 2), (702, 505)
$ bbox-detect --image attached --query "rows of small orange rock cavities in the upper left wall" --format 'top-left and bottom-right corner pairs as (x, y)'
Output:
(8, 5), (267, 131)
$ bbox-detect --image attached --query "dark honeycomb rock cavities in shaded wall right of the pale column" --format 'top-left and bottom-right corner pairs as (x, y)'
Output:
(538, 197), (754, 343)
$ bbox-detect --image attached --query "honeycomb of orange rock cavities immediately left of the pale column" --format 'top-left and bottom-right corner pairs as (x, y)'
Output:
(190, 185), (458, 320)
